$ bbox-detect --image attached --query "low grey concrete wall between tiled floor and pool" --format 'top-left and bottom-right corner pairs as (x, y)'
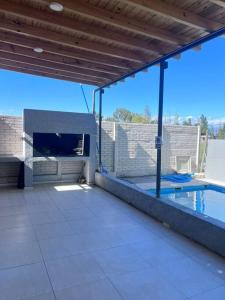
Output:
(95, 173), (225, 257)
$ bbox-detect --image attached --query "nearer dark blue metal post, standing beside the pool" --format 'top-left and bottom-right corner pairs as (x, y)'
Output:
(155, 61), (168, 198)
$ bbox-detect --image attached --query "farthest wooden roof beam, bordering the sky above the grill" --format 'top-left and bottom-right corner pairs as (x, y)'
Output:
(0, 64), (101, 86)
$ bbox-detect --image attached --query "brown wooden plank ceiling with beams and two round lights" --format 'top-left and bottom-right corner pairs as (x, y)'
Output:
(0, 0), (225, 86)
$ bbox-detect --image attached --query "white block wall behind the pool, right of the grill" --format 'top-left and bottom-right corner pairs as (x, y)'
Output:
(96, 122), (199, 177)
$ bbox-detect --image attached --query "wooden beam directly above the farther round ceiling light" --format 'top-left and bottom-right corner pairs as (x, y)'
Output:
(0, 30), (137, 72)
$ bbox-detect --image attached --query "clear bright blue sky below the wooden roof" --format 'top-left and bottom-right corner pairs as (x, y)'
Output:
(0, 38), (225, 119)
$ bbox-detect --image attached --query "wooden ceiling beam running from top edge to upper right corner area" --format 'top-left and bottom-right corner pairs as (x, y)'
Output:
(121, 0), (224, 31)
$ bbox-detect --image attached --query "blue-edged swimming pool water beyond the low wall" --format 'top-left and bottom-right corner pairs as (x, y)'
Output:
(149, 185), (225, 222)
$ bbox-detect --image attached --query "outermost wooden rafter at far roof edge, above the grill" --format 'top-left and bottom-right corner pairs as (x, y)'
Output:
(0, 64), (101, 86)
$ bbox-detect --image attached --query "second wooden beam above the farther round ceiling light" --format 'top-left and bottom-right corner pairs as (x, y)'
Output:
(0, 18), (148, 63)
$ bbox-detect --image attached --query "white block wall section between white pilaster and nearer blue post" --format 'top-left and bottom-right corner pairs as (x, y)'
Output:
(115, 124), (157, 176)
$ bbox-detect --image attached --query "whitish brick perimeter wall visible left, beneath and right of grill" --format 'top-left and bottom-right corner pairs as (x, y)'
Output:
(0, 116), (198, 183)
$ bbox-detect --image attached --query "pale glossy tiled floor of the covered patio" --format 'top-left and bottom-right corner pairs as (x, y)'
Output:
(0, 185), (225, 300)
